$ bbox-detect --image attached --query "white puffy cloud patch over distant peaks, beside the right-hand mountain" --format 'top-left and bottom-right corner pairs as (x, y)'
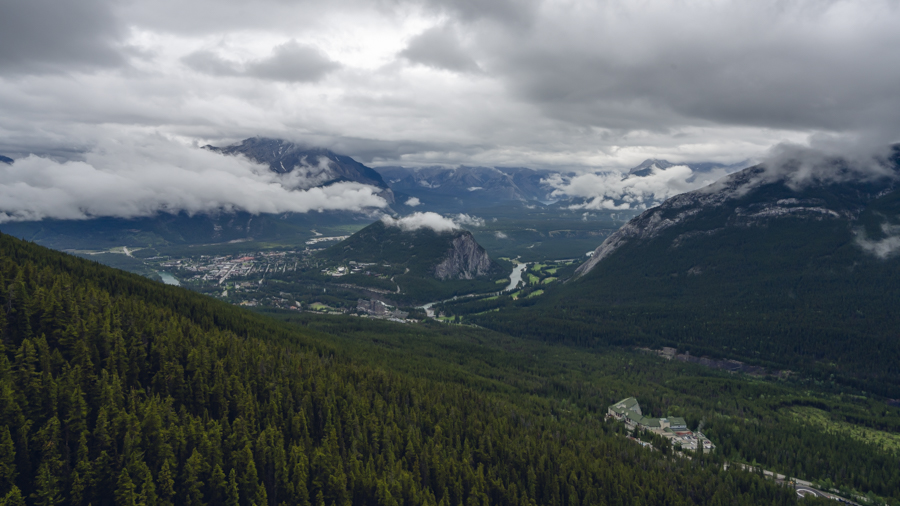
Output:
(543, 165), (729, 210)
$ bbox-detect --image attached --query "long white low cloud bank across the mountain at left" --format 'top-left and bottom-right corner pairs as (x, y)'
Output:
(0, 138), (387, 223)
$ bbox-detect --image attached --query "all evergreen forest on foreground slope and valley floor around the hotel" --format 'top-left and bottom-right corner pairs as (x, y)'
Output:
(0, 230), (900, 506)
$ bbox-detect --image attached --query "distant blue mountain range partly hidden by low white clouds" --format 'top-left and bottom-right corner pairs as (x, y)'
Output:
(0, 137), (744, 249)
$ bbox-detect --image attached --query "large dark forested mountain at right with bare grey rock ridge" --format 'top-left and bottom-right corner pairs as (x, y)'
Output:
(474, 149), (900, 398)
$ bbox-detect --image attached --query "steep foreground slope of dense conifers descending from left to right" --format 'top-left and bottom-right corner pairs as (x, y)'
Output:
(0, 235), (816, 505)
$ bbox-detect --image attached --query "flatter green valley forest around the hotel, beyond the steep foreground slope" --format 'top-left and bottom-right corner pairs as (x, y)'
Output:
(273, 312), (900, 504)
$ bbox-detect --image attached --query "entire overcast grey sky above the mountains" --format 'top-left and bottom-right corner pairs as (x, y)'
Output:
(0, 0), (900, 169)
